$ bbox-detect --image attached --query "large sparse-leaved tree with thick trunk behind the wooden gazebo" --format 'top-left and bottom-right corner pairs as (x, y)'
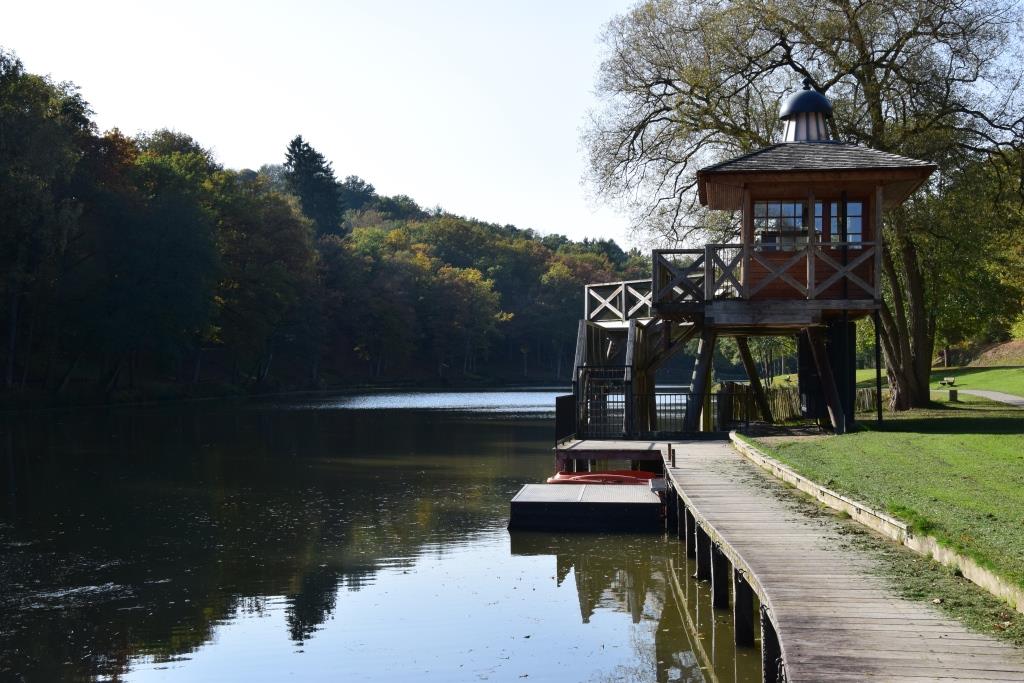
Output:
(585, 0), (1024, 409)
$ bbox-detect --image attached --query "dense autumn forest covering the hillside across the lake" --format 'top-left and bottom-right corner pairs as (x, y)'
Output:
(0, 52), (650, 396)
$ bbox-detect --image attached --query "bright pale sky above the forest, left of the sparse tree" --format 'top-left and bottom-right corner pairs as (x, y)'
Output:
(0, 0), (633, 245)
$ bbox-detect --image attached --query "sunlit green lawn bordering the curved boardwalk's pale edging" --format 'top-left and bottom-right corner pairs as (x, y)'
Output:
(755, 397), (1024, 587)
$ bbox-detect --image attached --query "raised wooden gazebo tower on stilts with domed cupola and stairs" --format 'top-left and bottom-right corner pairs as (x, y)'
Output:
(575, 81), (935, 437)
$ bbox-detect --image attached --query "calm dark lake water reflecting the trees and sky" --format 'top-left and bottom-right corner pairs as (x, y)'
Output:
(0, 391), (760, 681)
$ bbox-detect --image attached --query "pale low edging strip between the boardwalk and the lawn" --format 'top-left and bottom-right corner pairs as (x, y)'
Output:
(729, 431), (1024, 613)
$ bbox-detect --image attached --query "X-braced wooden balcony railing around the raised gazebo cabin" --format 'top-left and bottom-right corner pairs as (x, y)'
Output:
(652, 242), (881, 306)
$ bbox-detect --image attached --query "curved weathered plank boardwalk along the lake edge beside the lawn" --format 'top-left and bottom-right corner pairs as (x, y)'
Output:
(663, 441), (1024, 683)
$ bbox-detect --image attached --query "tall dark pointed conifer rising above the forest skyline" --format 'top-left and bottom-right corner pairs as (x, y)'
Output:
(285, 135), (343, 236)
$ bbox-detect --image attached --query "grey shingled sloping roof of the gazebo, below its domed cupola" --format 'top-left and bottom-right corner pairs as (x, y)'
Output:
(697, 141), (935, 175)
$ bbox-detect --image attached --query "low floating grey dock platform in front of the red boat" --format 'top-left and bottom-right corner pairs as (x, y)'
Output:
(509, 483), (665, 532)
